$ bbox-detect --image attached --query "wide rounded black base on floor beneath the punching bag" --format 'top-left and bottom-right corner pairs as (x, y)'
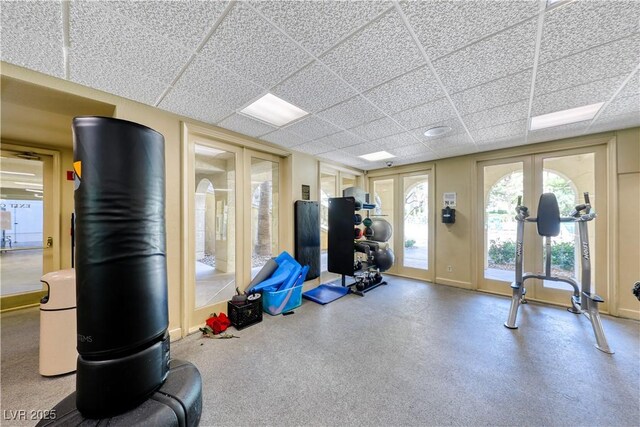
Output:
(37, 360), (202, 427)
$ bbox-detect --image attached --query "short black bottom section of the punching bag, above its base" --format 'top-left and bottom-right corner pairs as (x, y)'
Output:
(76, 333), (169, 418)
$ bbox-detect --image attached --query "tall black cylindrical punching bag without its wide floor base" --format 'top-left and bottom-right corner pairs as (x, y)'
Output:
(73, 117), (169, 418)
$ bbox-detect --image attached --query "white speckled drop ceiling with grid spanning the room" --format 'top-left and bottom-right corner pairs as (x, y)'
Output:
(0, 0), (640, 169)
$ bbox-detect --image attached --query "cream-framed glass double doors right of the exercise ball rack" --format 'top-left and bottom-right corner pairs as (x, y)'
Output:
(369, 170), (434, 281)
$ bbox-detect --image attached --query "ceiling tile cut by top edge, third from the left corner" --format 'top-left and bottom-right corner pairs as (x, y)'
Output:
(105, 0), (228, 51)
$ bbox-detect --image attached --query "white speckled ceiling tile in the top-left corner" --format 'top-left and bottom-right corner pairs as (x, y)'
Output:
(0, 1), (64, 77)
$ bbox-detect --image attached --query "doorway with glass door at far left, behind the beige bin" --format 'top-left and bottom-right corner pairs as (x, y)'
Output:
(0, 144), (59, 310)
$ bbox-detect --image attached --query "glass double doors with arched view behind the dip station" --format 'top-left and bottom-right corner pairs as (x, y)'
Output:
(477, 146), (609, 310)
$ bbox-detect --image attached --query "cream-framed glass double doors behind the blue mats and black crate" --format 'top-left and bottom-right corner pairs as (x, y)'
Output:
(183, 135), (282, 332)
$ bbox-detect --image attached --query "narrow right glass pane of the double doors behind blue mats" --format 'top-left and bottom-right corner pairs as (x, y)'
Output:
(250, 157), (280, 278)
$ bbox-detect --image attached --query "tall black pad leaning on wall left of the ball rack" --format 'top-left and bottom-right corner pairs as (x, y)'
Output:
(295, 200), (320, 280)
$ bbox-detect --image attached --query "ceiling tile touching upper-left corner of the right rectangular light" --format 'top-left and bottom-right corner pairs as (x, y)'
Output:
(451, 70), (532, 116)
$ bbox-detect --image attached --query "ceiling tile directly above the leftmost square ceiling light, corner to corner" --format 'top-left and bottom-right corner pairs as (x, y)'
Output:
(201, 3), (312, 88)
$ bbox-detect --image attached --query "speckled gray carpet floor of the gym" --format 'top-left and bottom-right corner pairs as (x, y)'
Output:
(1, 277), (640, 426)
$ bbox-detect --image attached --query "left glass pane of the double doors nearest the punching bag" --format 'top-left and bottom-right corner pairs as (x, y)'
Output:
(193, 144), (236, 308)
